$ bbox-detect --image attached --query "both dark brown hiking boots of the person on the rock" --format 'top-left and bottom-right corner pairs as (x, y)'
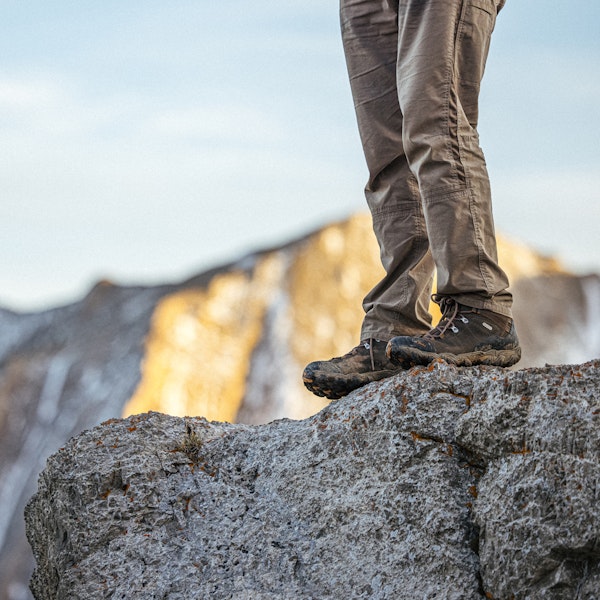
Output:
(302, 297), (521, 399)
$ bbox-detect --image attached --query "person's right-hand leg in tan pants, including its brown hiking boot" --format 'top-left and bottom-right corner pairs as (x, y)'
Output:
(387, 0), (520, 366)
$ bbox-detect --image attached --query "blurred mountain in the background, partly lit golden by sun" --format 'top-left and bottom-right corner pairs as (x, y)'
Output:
(0, 214), (600, 600)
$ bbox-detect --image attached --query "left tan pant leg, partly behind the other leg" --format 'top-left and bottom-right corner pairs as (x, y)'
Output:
(340, 0), (433, 340)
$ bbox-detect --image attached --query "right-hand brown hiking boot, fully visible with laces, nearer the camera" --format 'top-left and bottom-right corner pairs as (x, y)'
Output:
(387, 296), (521, 367)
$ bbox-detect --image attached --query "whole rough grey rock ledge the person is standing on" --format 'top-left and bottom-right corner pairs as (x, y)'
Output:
(26, 361), (600, 600)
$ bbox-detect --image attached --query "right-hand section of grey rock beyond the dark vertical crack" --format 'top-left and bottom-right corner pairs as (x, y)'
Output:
(457, 362), (600, 600)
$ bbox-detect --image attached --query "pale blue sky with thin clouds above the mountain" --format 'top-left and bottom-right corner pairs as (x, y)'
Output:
(0, 0), (600, 311)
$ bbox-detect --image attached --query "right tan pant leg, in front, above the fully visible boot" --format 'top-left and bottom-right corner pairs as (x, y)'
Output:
(397, 0), (512, 316)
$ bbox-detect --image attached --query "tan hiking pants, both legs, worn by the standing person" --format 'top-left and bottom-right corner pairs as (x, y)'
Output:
(340, 0), (512, 340)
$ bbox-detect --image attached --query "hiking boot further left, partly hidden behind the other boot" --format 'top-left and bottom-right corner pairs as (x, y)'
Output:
(302, 339), (402, 400)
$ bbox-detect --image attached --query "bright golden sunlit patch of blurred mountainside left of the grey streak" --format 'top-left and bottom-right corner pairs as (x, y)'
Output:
(127, 253), (284, 421)
